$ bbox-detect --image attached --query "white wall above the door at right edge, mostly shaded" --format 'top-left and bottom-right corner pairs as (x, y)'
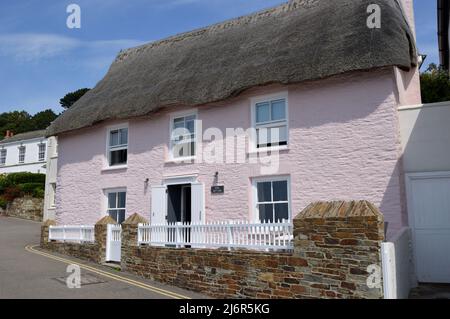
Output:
(399, 102), (450, 173)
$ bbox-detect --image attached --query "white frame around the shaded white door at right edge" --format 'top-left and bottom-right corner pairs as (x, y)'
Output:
(405, 171), (450, 285)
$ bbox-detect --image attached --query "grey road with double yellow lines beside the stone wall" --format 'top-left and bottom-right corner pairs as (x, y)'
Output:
(0, 216), (206, 299)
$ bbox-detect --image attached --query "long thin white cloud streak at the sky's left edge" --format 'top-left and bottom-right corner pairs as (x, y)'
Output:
(0, 33), (143, 62)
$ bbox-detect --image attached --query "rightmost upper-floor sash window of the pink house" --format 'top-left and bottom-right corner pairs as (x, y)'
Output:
(253, 96), (288, 149)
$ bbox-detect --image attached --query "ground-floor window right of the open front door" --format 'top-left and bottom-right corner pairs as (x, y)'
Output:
(253, 177), (291, 222)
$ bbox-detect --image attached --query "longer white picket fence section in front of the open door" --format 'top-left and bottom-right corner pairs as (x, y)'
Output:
(138, 221), (293, 250)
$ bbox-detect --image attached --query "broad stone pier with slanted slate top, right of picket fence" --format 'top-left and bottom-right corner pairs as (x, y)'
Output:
(291, 201), (384, 299)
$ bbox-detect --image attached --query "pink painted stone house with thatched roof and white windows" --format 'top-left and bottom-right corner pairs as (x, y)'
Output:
(48, 0), (420, 239)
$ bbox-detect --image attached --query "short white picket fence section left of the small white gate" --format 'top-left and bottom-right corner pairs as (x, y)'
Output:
(49, 226), (95, 243)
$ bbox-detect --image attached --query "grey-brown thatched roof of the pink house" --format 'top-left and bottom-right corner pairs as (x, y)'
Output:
(48, 0), (417, 135)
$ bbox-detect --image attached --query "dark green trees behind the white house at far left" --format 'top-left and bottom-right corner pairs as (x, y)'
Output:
(0, 109), (58, 140)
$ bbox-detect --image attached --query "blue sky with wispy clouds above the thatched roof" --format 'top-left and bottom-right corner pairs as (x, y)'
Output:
(0, 0), (439, 114)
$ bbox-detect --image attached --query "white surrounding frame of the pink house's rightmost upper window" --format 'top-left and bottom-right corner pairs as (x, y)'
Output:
(247, 91), (289, 153)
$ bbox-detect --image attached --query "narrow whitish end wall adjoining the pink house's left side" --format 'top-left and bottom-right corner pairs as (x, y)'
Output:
(44, 136), (58, 221)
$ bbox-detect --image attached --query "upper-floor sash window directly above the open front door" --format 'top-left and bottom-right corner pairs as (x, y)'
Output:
(170, 114), (197, 159)
